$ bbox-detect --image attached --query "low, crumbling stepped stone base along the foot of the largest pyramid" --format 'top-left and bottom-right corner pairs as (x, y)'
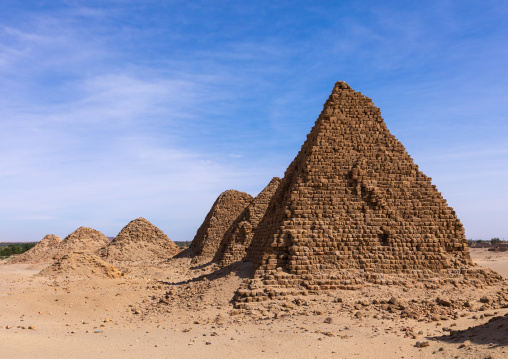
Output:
(233, 265), (503, 309)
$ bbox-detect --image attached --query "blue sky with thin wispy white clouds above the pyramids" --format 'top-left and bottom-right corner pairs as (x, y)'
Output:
(0, 0), (508, 241)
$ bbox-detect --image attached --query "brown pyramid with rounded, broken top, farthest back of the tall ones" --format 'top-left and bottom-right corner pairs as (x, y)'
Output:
(189, 190), (253, 259)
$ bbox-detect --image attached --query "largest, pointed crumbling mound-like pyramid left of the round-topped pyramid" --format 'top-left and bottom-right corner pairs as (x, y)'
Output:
(101, 218), (180, 262)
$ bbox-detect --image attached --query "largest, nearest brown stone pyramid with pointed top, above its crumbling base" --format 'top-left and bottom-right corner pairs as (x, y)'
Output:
(234, 82), (480, 296)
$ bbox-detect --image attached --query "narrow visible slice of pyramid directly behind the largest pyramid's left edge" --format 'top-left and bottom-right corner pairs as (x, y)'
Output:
(214, 177), (281, 267)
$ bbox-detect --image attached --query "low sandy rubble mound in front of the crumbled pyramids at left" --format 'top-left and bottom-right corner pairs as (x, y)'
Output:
(40, 252), (124, 278)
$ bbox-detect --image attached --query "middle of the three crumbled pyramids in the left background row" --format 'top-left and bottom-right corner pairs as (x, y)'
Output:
(57, 227), (109, 258)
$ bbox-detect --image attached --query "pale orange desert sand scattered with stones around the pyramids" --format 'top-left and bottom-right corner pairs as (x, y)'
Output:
(0, 249), (508, 359)
